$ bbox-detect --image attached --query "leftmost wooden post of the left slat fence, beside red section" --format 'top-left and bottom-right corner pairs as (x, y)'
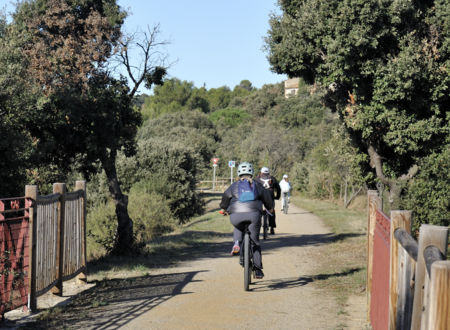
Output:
(25, 185), (38, 312)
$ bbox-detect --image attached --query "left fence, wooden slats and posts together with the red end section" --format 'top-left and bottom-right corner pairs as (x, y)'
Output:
(0, 181), (86, 316)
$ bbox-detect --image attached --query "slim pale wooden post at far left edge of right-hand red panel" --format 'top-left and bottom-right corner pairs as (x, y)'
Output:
(366, 190), (381, 322)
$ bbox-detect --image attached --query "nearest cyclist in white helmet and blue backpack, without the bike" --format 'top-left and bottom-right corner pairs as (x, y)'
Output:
(220, 162), (275, 279)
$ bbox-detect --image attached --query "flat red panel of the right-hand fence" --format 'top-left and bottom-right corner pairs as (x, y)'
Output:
(370, 210), (391, 330)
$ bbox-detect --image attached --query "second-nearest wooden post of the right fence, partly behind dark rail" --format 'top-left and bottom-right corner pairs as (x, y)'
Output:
(411, 225), (448, 330)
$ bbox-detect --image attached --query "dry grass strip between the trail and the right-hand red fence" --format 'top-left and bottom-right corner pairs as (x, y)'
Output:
(292, 196), (367, 314)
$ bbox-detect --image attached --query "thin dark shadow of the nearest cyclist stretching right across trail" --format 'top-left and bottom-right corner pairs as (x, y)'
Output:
(250, 268), (362, 292)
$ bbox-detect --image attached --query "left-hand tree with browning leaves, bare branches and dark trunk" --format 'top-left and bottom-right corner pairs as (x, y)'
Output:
(14, 0), (170, 253)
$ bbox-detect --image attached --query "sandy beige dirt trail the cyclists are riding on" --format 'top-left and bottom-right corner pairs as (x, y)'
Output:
(0, 201), (365, 330)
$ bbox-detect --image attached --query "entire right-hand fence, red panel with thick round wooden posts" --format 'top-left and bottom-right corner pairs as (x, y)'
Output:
(367, 191), (450, 330)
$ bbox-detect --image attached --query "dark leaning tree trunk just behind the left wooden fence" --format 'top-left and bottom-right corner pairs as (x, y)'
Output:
(102, 152), (134, 255)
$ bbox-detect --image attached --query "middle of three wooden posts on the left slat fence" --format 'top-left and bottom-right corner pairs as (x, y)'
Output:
(52, 183), (66, 296)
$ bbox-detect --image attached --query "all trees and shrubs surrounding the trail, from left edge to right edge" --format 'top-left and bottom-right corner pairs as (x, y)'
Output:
(0, 0), (450, 253)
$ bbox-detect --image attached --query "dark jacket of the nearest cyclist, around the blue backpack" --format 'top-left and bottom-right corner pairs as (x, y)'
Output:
(220, 180), (275, 214)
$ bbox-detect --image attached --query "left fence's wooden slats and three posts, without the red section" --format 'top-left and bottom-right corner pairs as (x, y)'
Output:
(18, 181), (86, 310)
